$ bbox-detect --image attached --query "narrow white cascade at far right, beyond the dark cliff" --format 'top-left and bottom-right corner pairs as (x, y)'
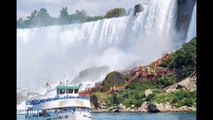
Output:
(186, 3), (197, 42)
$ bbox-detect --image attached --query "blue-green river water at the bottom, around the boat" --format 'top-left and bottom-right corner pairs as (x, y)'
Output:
(17, 112), (196, 120)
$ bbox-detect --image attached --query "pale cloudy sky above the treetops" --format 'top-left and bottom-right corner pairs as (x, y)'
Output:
(17, 0), (149, 19)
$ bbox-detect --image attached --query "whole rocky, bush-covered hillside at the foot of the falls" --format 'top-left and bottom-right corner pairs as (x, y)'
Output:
(90, 38), (197, 112)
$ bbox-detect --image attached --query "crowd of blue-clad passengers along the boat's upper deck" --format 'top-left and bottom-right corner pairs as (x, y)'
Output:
(26, 95), (89, 105)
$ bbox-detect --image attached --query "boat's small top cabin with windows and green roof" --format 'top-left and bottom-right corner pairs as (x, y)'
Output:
(56, 85), (80, 97)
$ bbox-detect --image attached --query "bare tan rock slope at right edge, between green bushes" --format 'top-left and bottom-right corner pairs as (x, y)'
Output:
(163, 75), (197, 93)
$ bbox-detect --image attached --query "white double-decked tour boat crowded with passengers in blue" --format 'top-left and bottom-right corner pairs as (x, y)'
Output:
(25, 85), (92, 120)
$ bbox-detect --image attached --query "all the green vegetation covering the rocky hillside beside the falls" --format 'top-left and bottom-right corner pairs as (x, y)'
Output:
(89, 38), (196, 108)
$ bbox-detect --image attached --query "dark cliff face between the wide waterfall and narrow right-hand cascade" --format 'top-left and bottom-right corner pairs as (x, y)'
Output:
(176, 0), (196, 42)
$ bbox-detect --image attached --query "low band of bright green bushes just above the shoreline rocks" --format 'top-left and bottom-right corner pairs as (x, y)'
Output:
(108, 83), (196, 107)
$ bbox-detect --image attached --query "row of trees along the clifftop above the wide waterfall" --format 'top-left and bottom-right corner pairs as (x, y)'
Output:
(17, 7), (129, 28)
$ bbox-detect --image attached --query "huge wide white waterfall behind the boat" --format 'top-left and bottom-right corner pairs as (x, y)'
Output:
(17, 0), (180, 87)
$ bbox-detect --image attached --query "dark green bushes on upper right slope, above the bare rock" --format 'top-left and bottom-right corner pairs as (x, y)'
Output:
(161, 37), (197, 81)
